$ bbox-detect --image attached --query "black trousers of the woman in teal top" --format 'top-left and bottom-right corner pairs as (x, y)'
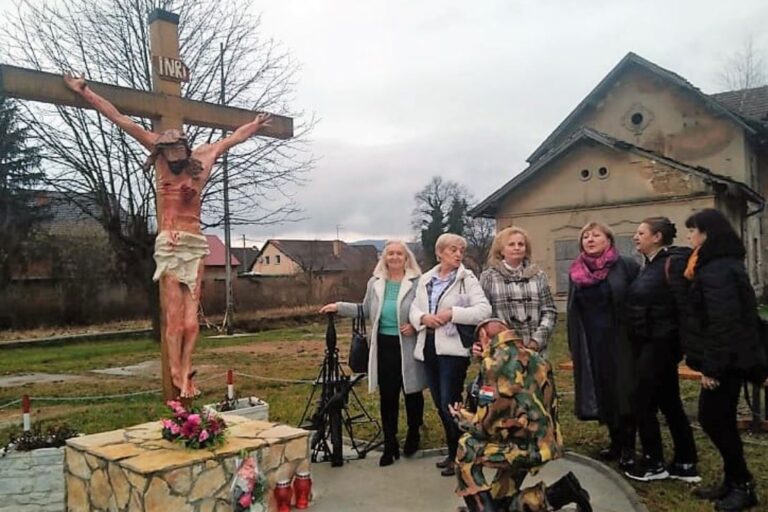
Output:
(376, 333), (424, 449)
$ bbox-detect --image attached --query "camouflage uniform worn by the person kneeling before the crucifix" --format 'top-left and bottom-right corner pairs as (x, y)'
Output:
(456, 330), (563, 511)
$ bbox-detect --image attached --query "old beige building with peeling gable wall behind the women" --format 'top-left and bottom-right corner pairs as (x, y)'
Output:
(472, 53), (768, 301)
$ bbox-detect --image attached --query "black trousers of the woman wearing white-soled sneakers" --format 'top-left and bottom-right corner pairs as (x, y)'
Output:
(635, 339), (698, 464)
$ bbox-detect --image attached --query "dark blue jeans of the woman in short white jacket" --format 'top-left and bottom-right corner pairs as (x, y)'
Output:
(424, 331), (469, 460)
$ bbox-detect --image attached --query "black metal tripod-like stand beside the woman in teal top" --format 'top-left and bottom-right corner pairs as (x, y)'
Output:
(299, 314), (384, 467)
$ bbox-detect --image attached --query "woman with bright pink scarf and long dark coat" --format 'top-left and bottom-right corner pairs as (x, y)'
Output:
(568, 222), (639, 469)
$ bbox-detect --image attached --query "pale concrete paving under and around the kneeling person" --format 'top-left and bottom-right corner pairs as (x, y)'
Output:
(309, 452), (647, 512)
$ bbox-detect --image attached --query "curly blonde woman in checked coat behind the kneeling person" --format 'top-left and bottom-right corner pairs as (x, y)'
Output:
(480, 226), (557, 351)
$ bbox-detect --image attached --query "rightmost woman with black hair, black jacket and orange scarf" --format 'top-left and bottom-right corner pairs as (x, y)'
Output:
(681, 209), (760, 511)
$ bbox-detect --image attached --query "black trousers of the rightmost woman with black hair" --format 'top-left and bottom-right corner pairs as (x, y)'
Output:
(699, 375), (752, 483)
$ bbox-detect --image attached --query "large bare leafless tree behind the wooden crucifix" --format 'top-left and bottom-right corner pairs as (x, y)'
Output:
(0, 0), (315, 328)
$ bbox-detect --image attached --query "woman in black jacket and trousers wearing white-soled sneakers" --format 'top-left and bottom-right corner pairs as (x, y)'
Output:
(626, 217), (701, 483)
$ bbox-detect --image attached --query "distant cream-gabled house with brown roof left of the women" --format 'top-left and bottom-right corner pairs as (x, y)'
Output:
(250, 239), (377, 276)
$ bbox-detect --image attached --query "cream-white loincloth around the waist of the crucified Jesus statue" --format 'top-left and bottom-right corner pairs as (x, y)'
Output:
(152, 231), (210, 297)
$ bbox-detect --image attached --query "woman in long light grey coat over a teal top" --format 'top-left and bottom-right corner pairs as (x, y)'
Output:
(320, 240), (426, 466)
